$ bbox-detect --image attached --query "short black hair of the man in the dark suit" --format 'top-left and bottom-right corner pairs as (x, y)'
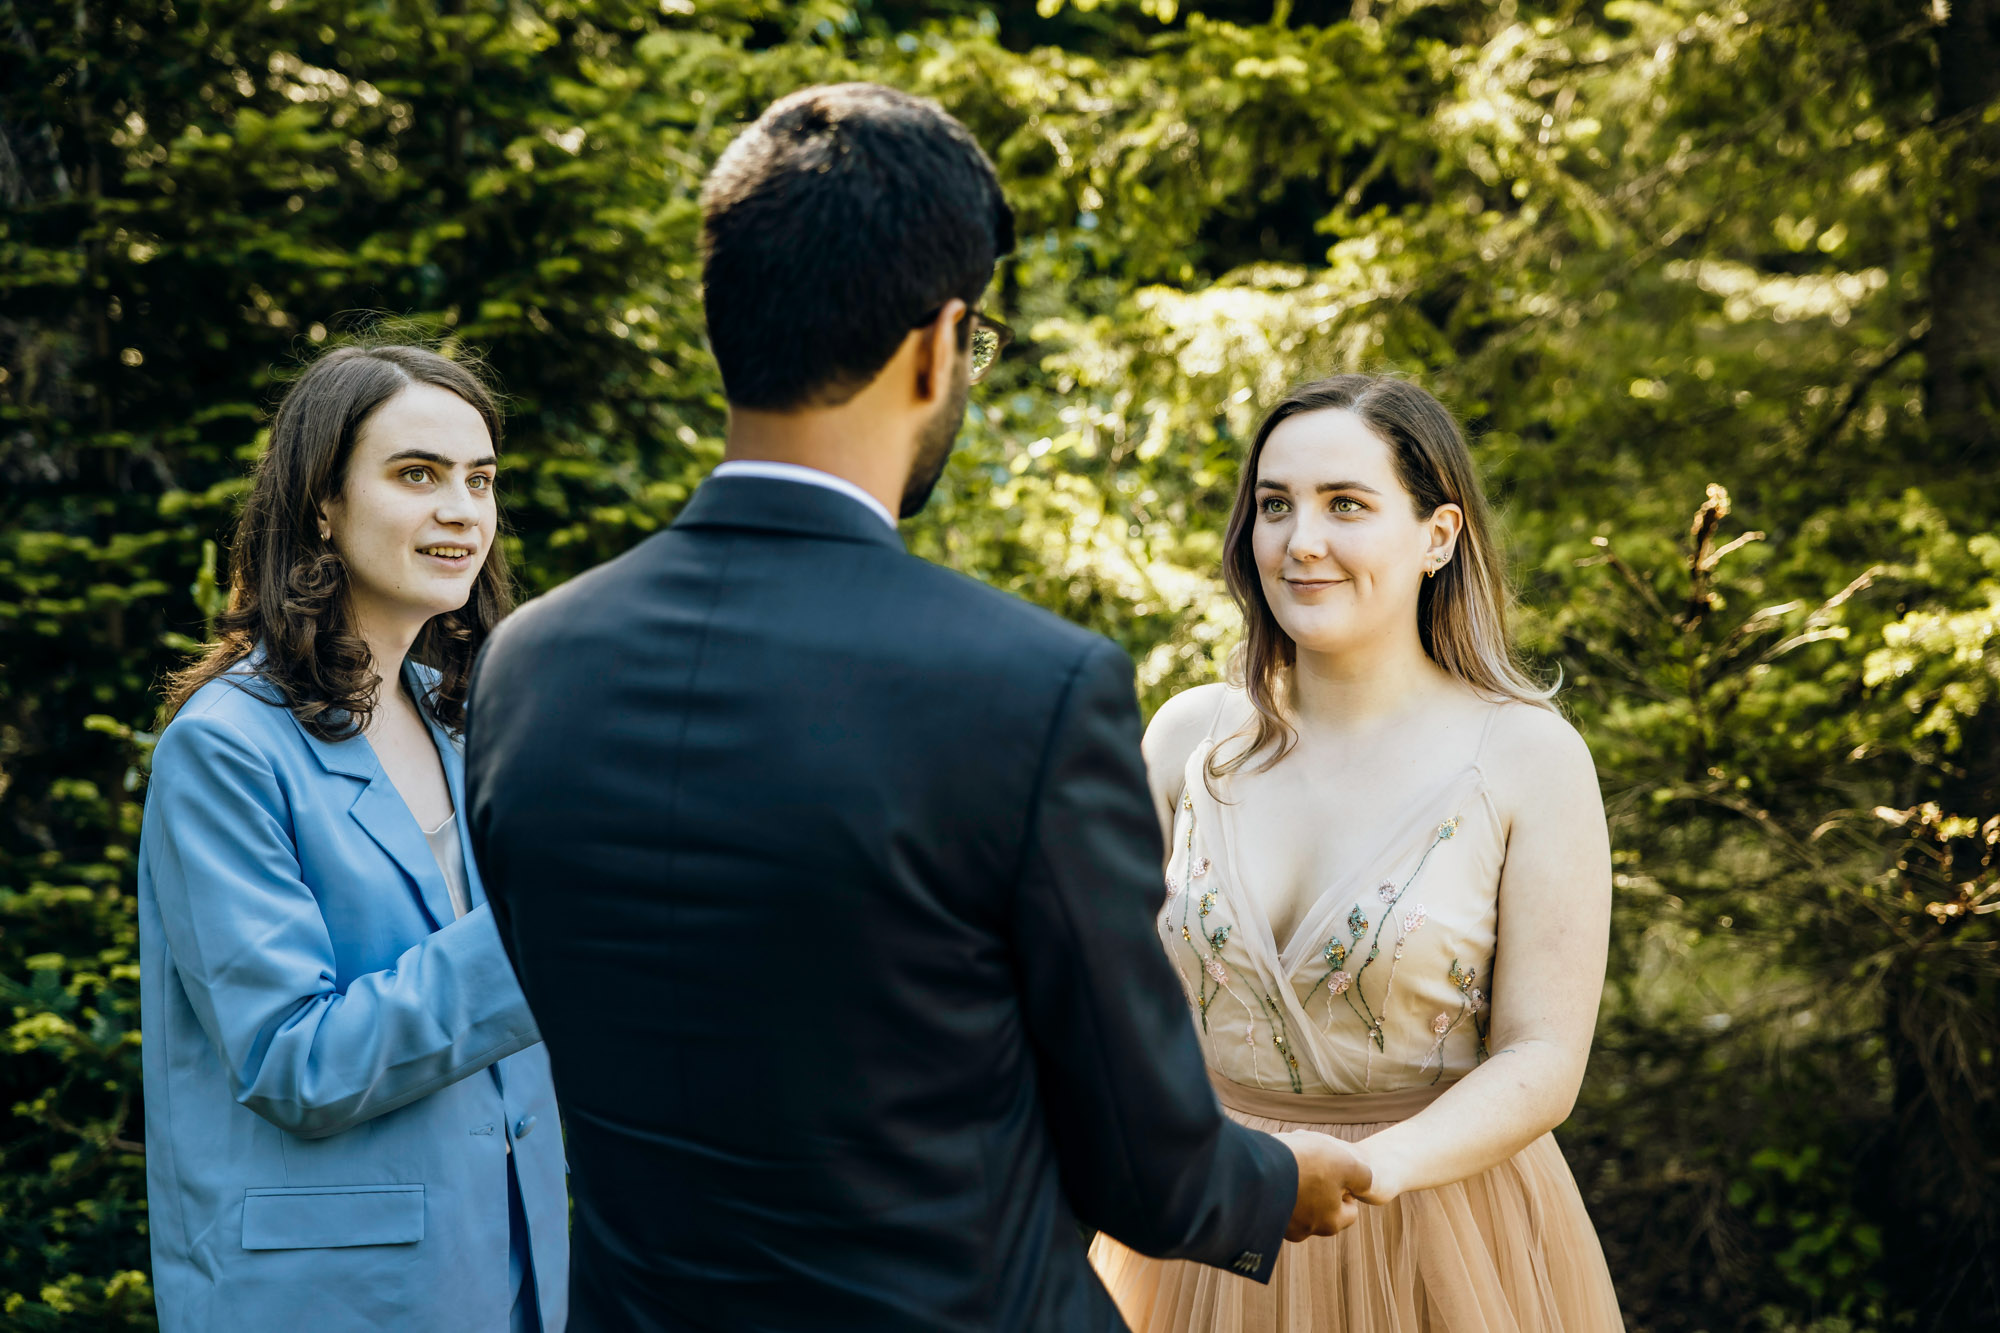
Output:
(702, 84), (1014, 412)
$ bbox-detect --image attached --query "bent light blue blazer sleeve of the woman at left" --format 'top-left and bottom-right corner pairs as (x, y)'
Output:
(146, 715), (540, 1139)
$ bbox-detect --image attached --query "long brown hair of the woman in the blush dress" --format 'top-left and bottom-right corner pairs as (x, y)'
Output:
(1206, 374), (1556, 783)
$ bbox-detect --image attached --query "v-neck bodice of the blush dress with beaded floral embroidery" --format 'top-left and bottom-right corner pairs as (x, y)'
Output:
(1160, 707), (1506, 1095)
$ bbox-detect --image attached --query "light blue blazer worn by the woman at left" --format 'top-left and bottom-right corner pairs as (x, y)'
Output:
(138, 667), (570, 1333)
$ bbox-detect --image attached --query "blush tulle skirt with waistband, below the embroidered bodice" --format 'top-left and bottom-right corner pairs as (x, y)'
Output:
(1090, 1079), (1624, 1333)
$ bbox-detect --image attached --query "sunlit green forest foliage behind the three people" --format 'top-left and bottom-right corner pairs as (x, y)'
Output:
(0, 0), (2000, 1333)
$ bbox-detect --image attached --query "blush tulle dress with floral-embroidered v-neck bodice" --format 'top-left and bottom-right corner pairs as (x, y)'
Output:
(1090, 705), (1624, 1333)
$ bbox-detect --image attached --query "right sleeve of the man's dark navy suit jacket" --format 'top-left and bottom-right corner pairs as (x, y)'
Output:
(1014, 640), (1298, 1281)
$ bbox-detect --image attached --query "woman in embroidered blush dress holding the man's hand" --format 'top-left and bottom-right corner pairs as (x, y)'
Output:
(1092, 374), (1624, 1333)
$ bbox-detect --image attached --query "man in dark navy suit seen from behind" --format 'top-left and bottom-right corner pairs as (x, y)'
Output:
(468, 84), (1368, 1333)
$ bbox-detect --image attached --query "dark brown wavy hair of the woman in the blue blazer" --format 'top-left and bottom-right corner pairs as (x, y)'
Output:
(160, 342), (514, 741)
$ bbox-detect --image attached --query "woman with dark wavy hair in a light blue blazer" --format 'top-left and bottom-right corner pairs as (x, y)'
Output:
(138, 346), (568, 1333)
